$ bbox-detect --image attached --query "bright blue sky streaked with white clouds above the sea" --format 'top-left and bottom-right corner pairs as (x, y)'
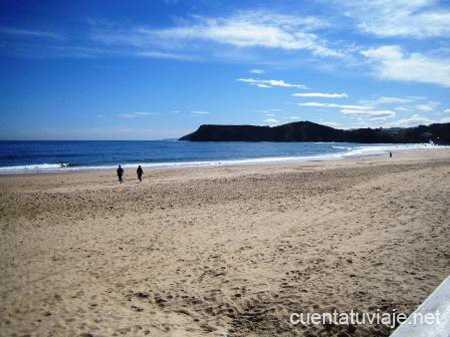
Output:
(0, 0), (450, 140)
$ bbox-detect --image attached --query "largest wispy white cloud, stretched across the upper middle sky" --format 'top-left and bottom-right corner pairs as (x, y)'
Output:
(91, 11), (344, 57)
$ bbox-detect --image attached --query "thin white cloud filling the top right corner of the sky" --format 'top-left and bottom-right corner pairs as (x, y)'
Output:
(332, 0), (450, 38)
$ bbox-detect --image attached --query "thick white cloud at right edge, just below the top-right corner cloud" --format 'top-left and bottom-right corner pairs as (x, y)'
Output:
(361, 46), (450, 87)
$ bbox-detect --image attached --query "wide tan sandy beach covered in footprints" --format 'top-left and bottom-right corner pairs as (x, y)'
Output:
(0, 149), (450, 337)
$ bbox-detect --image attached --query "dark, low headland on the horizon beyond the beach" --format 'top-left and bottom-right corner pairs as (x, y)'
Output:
(179, 122), (450, 144)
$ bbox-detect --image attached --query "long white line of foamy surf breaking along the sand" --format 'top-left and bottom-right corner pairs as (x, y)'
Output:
(0, 144), (442, 175)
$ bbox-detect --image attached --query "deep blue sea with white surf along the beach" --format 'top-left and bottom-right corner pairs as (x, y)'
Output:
(0, 140), (442, 174)
